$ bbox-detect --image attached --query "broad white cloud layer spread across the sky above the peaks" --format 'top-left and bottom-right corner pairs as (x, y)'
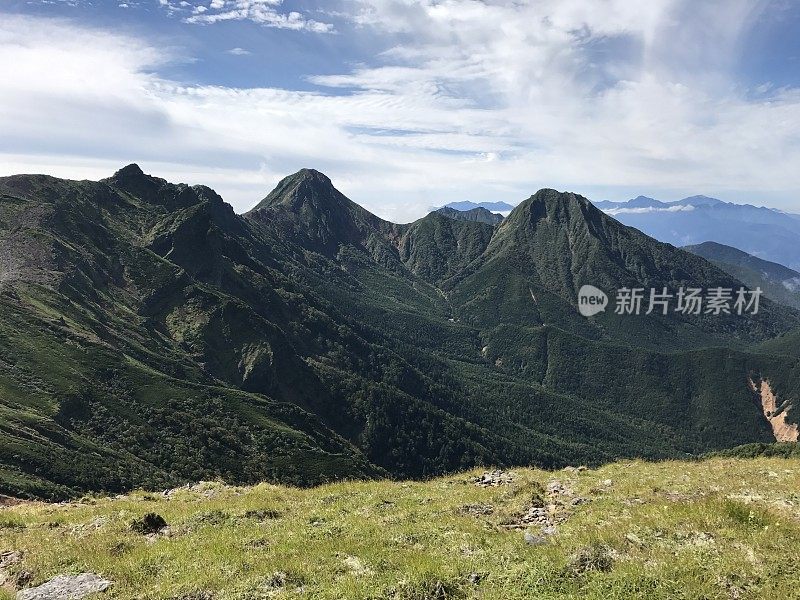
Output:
(0, 0), (800, 220)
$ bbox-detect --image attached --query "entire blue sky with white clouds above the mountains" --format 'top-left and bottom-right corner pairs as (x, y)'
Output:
(0, 0), (800, 222)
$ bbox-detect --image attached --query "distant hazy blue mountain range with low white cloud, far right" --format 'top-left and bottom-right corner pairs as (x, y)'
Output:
(594, 196), (800, 270)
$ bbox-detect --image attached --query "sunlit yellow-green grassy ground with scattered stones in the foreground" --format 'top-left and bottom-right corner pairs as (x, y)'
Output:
(0, 458), (800, 600)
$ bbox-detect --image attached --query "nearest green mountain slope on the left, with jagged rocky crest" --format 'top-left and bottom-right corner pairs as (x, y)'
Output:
(0, 169), (380, 495)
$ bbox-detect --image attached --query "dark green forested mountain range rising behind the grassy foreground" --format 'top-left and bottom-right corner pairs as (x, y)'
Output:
(0, 165), (800, 497)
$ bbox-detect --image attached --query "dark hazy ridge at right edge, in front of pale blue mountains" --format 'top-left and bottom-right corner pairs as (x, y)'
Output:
(684, 242), (800, 309)
